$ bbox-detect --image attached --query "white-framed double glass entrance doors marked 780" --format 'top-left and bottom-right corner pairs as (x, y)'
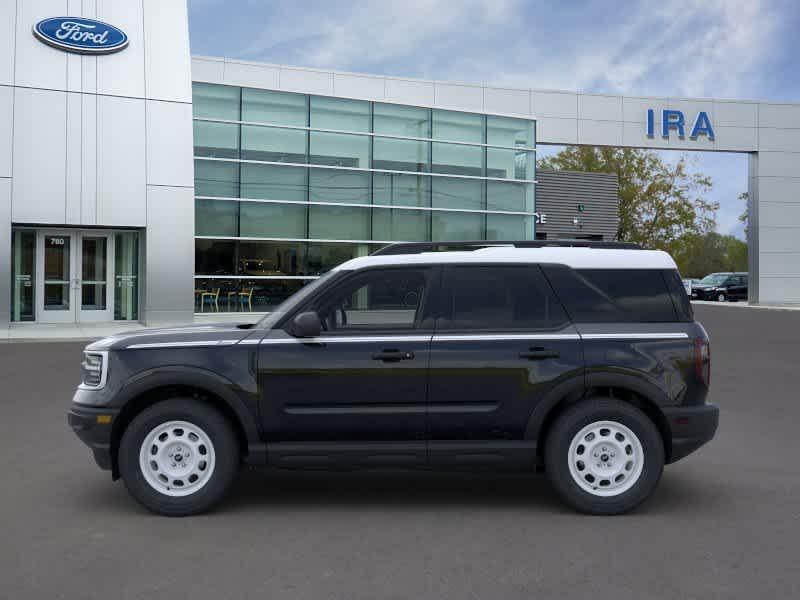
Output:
(36, 230), (114, 323)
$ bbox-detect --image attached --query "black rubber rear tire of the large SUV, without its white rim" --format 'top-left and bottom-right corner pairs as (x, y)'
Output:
(545, 398), (664, 515)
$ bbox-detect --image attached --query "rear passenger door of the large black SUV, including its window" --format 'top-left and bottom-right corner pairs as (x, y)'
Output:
(428, 265), (583, 464)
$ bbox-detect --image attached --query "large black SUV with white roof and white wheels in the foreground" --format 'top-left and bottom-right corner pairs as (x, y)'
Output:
(69, 240), (718, 516)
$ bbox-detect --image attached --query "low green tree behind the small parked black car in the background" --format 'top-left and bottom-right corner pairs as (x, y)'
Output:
(664, 231), (747, 278)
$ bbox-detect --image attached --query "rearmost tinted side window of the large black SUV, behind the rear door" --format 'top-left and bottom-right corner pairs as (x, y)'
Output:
(543, 266), (685, 323)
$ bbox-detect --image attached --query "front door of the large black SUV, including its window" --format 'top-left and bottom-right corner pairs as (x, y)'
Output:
(258, 267), (432, 464)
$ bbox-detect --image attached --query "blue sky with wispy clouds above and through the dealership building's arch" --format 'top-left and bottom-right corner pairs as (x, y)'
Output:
(189, 0), (800, 237)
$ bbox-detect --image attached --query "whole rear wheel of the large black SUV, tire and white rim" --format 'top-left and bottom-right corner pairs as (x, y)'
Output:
(545, 398), (664, 515)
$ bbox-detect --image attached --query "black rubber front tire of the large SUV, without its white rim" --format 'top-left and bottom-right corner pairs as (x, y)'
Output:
(119, 398), (240, 516)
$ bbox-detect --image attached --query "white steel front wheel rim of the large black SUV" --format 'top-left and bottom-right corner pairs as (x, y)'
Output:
(139, 421), (215, 497)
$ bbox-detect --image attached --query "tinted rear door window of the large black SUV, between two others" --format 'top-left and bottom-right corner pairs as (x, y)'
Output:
(436, 265), (568, 331)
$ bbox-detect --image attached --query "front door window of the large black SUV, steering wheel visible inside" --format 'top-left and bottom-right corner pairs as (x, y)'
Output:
(315, 268), (427, 333)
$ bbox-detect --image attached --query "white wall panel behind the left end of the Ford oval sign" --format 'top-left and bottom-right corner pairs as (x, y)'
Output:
(13, 0), (67, 90)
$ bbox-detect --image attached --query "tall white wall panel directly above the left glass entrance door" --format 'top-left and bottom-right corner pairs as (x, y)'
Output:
(11, 87), (67, 223)
